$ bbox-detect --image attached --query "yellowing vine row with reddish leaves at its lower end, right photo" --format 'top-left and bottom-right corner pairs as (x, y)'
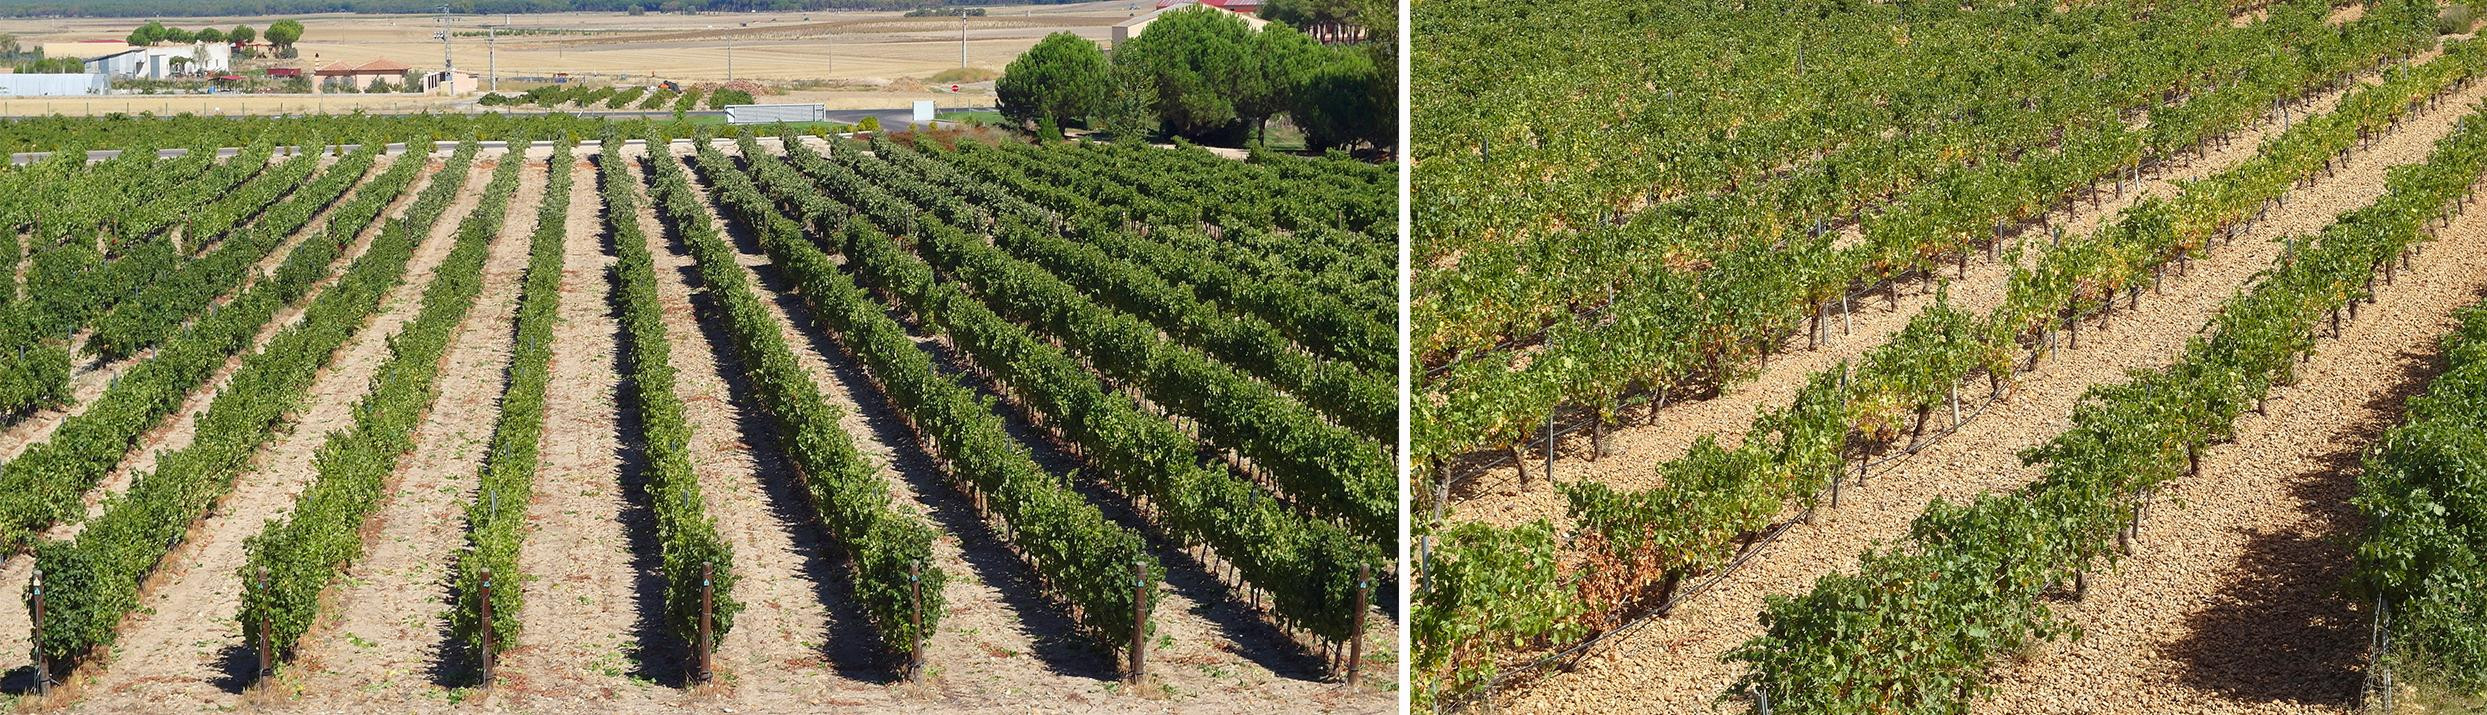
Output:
(1413, 32), (2487, 712)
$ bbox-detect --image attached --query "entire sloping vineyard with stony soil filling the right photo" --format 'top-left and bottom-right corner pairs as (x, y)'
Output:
(1408, 2), (2487, 713)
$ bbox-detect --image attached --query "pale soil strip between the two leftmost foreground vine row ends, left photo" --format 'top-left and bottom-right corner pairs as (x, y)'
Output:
(80, 159), (492, 713)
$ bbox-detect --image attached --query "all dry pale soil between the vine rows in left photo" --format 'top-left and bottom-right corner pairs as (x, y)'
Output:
(0, 137), (1398, 713)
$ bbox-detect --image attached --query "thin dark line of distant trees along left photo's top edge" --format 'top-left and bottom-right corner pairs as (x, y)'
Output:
(0, 0), (1084, 17)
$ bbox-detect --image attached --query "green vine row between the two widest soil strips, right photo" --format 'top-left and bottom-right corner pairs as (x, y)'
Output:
(1731, 96), (2487, 713)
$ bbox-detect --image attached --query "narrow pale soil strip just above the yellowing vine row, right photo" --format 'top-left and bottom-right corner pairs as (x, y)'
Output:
(1452, 50), (2397, 526)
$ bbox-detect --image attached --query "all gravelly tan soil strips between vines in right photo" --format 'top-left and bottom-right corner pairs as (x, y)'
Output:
(1455, 32), (2487, 713)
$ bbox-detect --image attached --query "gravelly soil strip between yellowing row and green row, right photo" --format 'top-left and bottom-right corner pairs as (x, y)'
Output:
(1462, 54), (2487, 713)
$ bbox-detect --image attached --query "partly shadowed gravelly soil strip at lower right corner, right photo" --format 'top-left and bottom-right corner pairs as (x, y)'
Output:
(1982, 137), (2487, 713)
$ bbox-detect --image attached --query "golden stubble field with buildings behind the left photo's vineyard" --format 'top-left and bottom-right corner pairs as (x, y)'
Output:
(0, 0), (1156, 115)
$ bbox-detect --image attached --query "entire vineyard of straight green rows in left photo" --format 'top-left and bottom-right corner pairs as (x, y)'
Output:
(0, 112), (1398, 713)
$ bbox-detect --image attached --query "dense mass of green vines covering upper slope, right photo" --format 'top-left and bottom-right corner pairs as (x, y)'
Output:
(1410, 0), (2435, 483)
